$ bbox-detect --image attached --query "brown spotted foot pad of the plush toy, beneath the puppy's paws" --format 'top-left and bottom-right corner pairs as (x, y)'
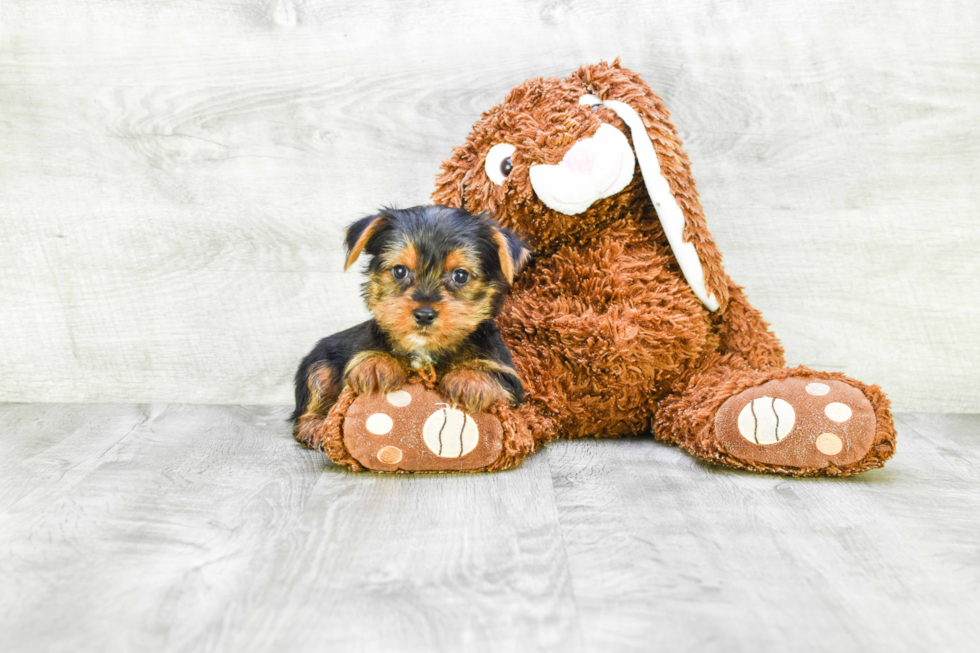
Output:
(343, 384), (503, 472)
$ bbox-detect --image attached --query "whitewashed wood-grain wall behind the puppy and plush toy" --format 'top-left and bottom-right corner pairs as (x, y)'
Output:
(0, 0), (980, 411)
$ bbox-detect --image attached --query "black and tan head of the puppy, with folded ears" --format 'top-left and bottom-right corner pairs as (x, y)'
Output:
(344, 206), (530, 356)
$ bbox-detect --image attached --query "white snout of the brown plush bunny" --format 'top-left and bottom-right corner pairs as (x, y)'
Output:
(529, 123), (636, 215)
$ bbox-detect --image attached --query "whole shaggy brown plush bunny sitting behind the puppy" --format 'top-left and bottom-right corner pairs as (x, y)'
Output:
(312, 60), (895, 476)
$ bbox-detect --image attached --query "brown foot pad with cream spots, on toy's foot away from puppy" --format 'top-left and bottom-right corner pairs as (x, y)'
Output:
(715, 377), (875, 468)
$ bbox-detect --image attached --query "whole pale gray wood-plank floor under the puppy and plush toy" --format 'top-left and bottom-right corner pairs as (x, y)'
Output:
(0, 404), (980, 652)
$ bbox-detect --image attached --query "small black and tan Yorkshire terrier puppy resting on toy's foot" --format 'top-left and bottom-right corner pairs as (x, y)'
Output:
(292, 206), (530, 421)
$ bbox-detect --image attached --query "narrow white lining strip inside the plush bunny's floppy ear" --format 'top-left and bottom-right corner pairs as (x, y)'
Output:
(602, 100), (719, 311)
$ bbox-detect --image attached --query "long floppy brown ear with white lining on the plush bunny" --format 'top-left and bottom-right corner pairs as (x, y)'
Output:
(572, 59), (731, 311)
